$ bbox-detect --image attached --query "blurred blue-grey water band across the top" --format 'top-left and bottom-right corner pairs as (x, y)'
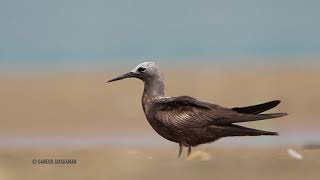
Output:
(0, 0), (320, 69)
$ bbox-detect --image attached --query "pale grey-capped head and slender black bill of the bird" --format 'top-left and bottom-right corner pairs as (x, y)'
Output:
(107, 62), (161, 82)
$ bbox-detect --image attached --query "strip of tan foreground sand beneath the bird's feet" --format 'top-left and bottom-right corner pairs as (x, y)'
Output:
(0, 147), (320, 180)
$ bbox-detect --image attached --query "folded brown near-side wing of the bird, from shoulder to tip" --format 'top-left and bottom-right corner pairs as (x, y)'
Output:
(150, 96), (285, 129)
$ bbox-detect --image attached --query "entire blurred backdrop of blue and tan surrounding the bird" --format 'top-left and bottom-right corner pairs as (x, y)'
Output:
(0, 0), (320, 179)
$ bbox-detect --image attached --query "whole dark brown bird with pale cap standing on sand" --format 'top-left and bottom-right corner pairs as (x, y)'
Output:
(107, 62), (287, 158)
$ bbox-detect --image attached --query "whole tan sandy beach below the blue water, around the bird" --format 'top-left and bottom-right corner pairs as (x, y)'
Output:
(0, 66), (320, 180)
